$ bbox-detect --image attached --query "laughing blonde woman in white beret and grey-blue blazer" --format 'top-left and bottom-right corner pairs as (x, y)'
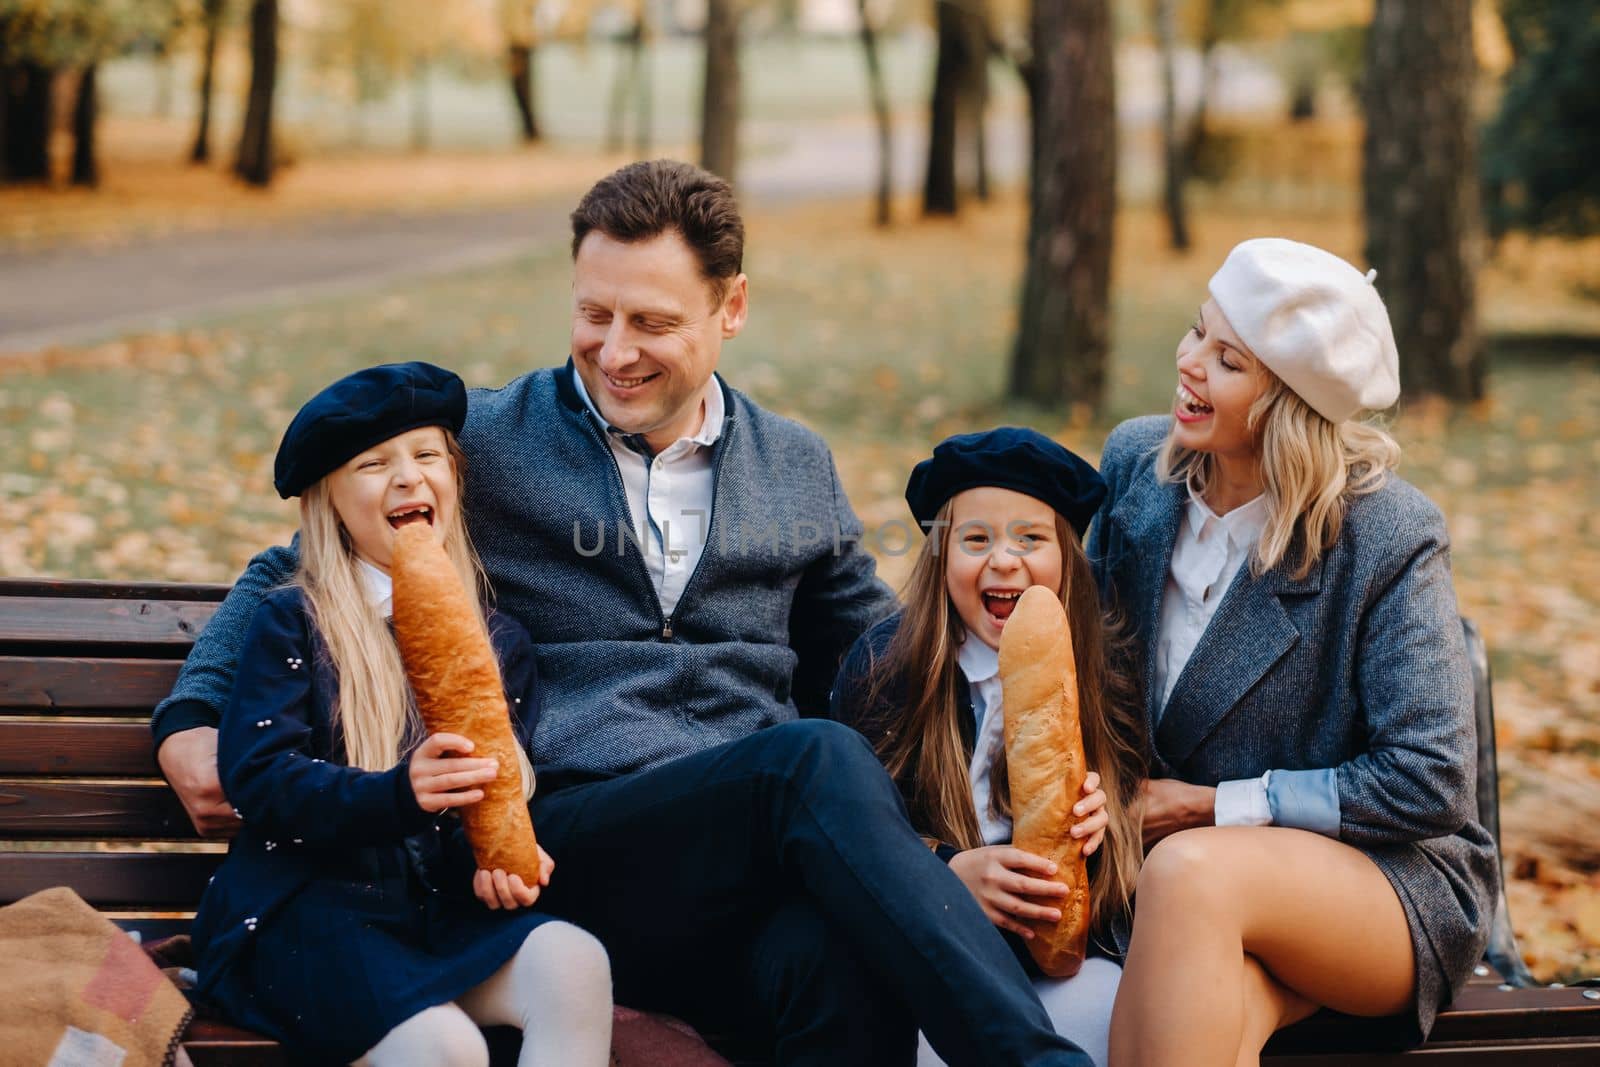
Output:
(1091, 238), (1494, 1067)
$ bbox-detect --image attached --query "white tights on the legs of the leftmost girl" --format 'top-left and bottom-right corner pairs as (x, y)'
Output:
(355, 921), (611, 1067)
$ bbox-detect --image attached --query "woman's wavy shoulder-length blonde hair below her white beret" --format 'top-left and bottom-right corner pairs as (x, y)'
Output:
(1155, 366), (1400, 579)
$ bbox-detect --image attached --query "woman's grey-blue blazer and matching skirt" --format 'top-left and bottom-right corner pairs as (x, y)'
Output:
(1090, 416), (1496, 1040)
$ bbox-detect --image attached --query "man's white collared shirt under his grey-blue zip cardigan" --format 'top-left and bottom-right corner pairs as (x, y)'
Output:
(573, 371), (726, 616)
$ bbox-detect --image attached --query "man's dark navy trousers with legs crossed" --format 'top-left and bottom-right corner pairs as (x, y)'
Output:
(533, 720), (1091, 1067)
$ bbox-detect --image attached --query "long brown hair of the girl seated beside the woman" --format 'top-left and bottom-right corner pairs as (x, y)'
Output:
(866, 501), (1149, 929)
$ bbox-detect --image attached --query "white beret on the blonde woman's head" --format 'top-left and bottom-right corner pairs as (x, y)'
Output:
(1211, 237), (1400, 422)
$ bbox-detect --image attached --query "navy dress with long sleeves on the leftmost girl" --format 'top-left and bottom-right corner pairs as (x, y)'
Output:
(194, 589), (552, 1064)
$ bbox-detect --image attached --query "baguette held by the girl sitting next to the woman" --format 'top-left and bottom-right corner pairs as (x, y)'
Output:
(1000, 585), (1090, 977)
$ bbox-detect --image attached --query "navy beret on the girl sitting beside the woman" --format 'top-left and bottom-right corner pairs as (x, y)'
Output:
(906, 426), (1106, 537)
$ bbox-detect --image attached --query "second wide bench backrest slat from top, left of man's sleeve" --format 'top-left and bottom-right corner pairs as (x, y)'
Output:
(0, 655), (182, 718)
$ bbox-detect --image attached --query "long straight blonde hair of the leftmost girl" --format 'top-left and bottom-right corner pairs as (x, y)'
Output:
(294, 430), (533, 797)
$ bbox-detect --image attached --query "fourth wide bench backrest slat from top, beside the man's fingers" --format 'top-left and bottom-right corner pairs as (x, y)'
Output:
(0, 777), (195, 841)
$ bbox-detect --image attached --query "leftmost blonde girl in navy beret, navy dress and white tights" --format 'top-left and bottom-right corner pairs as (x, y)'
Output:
(194, 363), (611, 1067)
